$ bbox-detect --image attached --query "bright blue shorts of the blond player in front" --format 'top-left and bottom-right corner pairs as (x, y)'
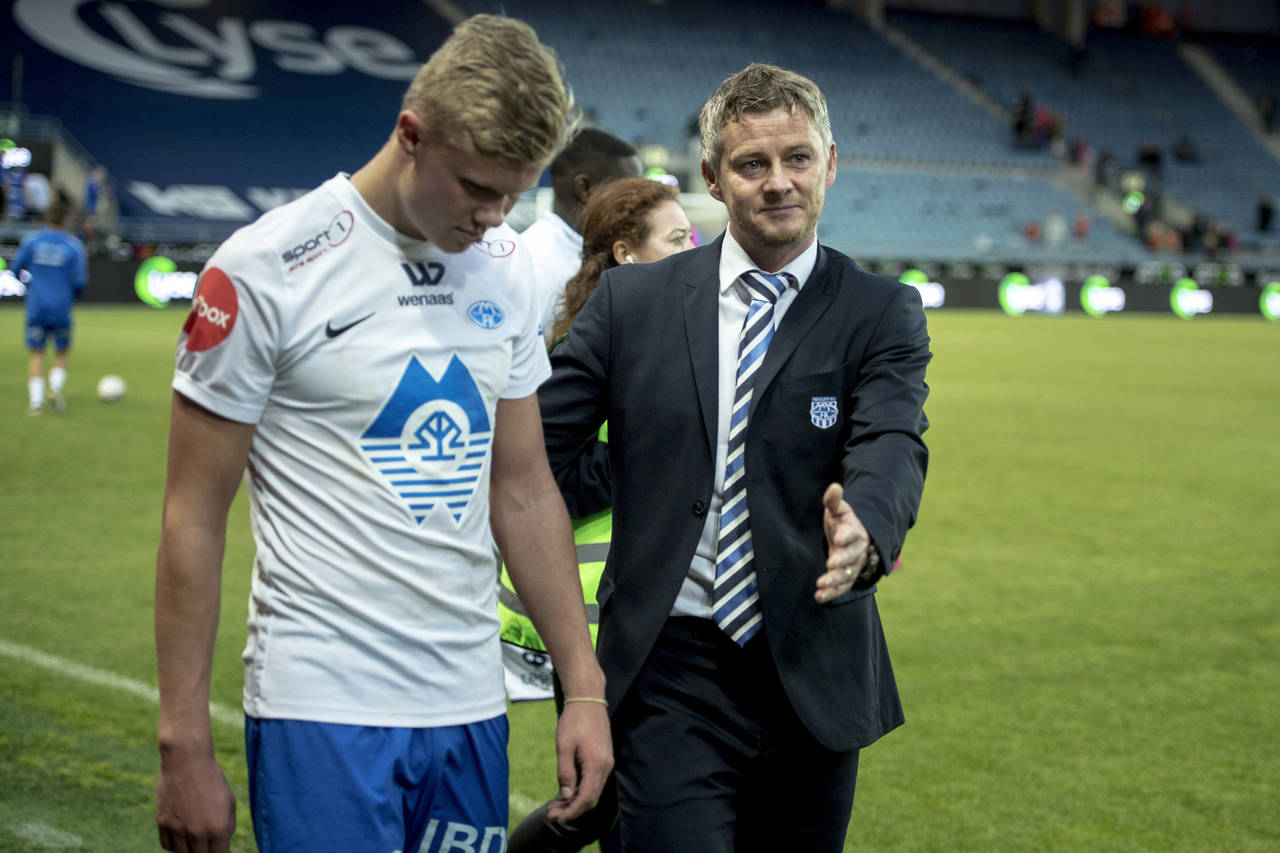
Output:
(244, 715), (508, 853)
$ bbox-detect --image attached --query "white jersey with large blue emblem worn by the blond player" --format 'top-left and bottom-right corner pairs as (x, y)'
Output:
(173, 174), (550, 726)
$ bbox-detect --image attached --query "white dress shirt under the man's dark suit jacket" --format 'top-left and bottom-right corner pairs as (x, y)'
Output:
(671, 231), (818, 619)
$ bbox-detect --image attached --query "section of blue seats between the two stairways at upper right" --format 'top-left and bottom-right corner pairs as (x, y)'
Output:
(888, 12), (1280, 248)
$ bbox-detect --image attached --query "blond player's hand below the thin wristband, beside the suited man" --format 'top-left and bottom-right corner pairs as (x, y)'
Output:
(547, 702), (613, 824)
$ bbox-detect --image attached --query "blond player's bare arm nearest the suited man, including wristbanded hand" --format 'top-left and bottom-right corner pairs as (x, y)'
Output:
(490, 396), (613, 821)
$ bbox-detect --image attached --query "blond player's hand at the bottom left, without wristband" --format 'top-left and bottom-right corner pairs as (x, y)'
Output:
(156, 751), (236, 853)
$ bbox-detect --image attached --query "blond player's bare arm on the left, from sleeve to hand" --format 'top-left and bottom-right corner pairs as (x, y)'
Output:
(155, 393), (253, 850)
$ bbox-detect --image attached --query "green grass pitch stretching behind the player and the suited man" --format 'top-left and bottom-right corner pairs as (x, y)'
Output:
(0, 307), (1280, 853)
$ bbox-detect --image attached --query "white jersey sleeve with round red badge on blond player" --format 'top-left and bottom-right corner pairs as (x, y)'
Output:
(173, 231), (289, 424)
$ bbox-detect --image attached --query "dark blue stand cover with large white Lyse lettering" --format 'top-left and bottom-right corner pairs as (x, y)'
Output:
(3, 0), (451, 222)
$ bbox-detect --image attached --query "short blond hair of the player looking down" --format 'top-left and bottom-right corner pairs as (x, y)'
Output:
(402, 14), (579, 164)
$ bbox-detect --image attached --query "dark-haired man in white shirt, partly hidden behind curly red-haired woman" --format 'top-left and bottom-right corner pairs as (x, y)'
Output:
(521, 127), (640, 346)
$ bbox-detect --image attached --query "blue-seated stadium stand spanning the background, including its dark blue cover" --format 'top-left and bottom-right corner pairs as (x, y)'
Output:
(2, 0), (1280, 264)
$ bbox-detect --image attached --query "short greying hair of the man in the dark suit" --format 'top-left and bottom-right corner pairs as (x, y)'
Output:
(698, 63), (832, 169)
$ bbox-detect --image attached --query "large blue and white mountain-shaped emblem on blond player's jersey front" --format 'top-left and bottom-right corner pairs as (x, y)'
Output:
(360, 355), (493, 524)
